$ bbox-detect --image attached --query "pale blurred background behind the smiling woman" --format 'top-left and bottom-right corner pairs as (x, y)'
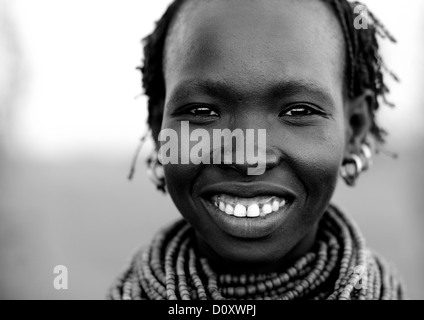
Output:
(0, 0), (424, 299)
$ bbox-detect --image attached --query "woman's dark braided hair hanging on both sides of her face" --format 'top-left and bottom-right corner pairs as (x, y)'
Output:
(137, 0), (397, 147)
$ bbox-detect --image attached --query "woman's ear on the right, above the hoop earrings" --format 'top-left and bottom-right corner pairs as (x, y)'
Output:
(345, 89), (374, 157)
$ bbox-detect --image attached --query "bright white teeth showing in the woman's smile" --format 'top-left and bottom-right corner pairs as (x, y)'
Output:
(211, 194), (287, 218)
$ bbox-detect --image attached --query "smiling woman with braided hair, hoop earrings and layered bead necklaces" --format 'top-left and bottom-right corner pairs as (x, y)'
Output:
(110, 0), (405, 300)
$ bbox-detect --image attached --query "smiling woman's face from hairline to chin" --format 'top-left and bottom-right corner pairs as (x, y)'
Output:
(162, 0), (346, 271)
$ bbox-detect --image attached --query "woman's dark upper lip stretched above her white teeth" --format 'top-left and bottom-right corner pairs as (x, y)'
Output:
(200, 181), (295, 200)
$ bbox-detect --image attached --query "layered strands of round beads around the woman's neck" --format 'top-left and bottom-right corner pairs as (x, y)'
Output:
(108, 206), (405, 300)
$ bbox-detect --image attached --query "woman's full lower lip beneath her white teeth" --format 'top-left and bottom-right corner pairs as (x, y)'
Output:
(202, 199), (290, 239)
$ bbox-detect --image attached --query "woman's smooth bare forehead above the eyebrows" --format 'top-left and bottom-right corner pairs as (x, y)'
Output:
(164, 0), (345, 101)
